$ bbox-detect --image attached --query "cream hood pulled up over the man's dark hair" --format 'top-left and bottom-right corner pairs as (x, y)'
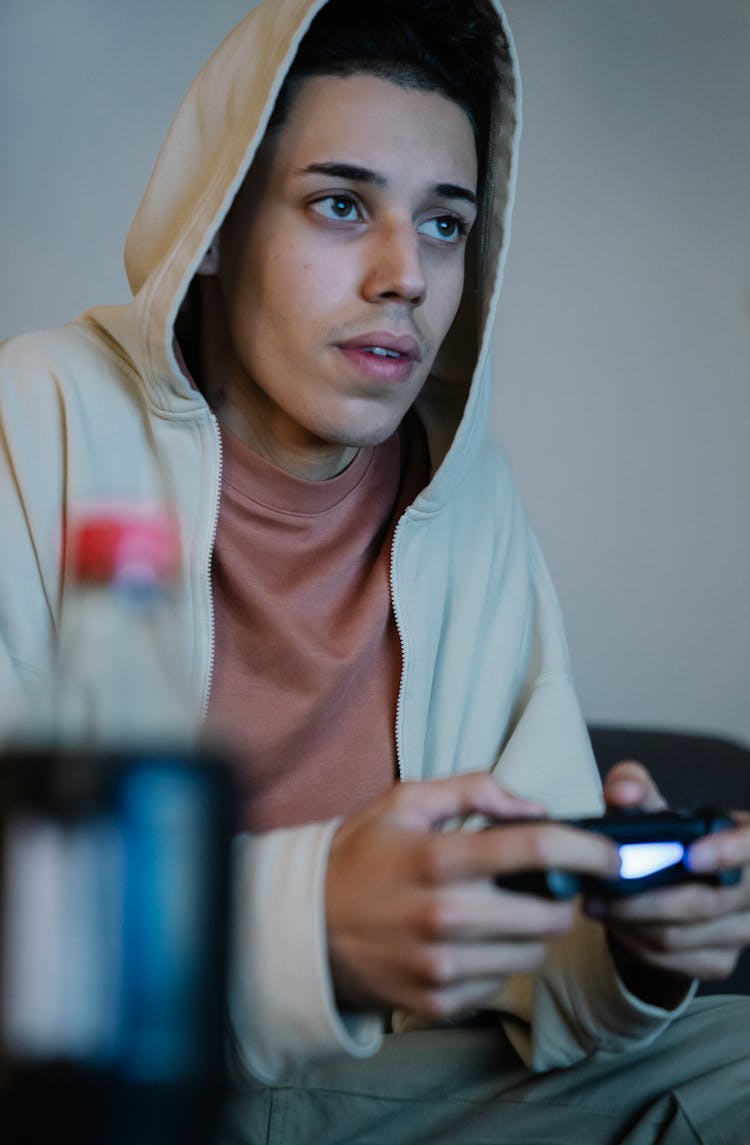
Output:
(99, 0), (520, 487)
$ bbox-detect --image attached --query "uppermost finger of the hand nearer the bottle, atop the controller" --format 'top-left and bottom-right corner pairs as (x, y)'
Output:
(389, 772), (544, 830)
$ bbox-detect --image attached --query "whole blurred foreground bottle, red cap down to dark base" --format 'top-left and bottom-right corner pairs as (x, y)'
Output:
(0, 510), (231, 1145)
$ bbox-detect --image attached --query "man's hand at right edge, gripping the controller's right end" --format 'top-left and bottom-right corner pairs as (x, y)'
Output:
(586, 763), (750, 1005)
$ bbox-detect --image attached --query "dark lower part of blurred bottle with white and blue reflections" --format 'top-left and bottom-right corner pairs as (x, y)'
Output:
(0, 751), (232, 1145)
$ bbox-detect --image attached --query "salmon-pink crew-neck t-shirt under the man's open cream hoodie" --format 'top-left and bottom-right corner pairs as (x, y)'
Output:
(208, 413), (429, 831)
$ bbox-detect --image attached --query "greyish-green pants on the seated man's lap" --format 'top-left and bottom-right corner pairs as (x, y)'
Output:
(219, 996), (750, 1145)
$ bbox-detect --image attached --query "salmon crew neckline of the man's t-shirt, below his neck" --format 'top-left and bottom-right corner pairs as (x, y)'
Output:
(221, 426), (374, 516)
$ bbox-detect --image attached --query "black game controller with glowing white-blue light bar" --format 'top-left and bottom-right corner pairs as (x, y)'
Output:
(494, 807), (742, 899)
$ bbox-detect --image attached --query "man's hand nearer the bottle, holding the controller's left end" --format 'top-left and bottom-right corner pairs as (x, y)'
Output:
(326, 773), (618, 1019)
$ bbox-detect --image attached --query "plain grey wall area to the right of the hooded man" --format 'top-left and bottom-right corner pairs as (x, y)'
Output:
(495, 0), (750, 741)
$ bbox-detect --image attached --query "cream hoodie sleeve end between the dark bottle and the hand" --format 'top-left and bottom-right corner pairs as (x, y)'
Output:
(229, 820), (384, 1083)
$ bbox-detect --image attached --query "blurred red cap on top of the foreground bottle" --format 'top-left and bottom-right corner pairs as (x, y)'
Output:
(68, 507), (181, 585)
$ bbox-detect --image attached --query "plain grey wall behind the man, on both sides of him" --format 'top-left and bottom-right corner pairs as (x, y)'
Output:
(0, 0), (750, 742)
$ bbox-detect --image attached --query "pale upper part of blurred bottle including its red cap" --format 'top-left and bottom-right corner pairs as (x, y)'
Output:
(54, 508), (199, 751)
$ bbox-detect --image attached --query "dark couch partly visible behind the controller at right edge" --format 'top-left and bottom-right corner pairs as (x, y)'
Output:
(589, 725), (750, 994)
